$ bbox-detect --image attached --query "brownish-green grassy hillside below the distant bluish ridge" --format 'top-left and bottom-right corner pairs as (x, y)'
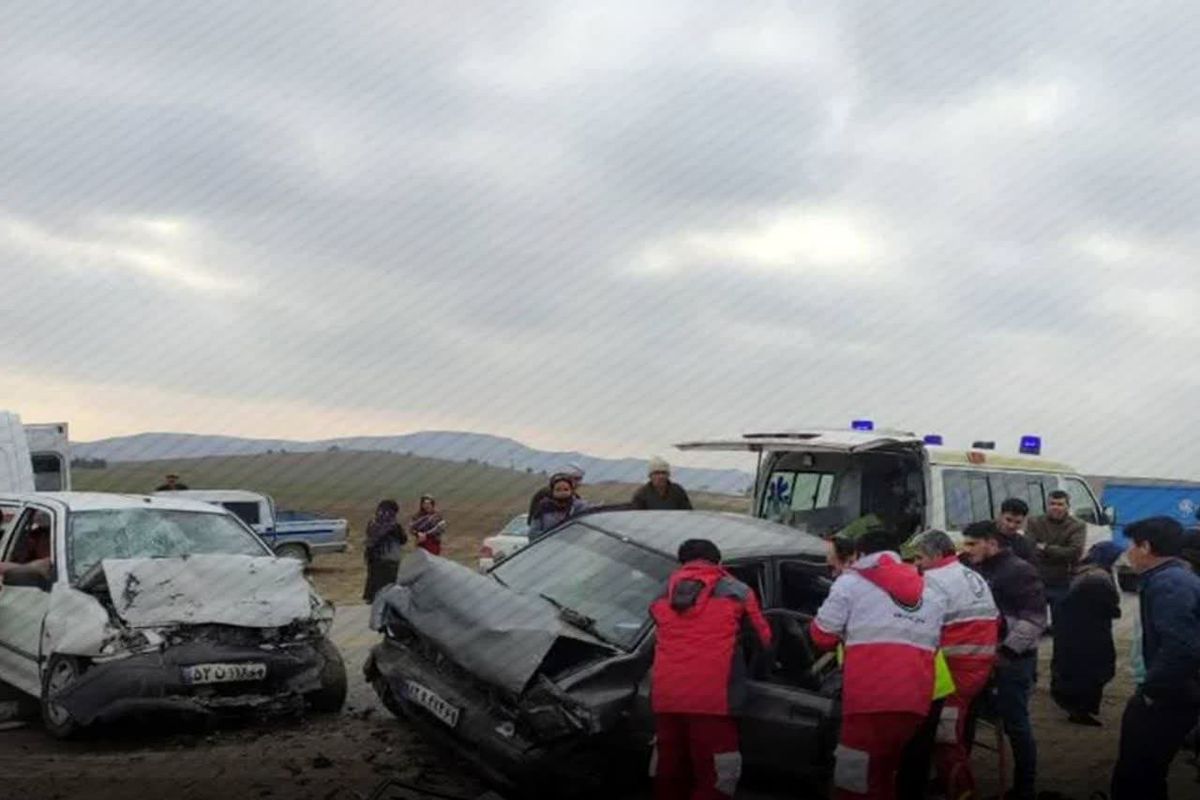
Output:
(72, 451), (748, 602)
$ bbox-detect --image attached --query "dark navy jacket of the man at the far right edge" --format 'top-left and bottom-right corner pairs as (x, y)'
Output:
(1139, 560), (1200, 704)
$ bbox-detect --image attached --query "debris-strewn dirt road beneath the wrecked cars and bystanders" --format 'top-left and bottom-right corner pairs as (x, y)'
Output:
(0, 597), (1198, 800)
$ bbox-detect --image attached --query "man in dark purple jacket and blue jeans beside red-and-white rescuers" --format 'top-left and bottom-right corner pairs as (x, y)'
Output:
(962, 522), (1046, 800)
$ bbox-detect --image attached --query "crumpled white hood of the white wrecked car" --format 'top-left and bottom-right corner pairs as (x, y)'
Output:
(102, 555), (313, 627)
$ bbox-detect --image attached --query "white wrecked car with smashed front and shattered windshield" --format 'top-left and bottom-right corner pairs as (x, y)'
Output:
(0, 493), (347, 736)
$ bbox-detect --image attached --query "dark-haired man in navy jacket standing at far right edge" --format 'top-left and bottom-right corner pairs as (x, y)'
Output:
(1112, 517), (1200, 800)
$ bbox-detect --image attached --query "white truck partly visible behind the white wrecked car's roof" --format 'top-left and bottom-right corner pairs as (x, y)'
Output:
(0, 411), (71, 493)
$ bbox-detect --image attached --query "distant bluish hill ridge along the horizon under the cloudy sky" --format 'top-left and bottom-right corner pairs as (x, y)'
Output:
(71, 431), (754, 494)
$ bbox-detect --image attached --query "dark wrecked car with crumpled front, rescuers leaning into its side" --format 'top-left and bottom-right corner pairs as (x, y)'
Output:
(365, 511), (839, 796)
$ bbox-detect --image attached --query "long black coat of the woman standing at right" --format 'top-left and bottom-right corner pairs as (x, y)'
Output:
(1051, 570), (1121, 692)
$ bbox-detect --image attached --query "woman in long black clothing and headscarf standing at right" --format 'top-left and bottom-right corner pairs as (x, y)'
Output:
(1050, 541), (1121, 727)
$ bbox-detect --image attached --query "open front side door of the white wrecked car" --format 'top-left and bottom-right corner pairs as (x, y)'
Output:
(0, 505), (62, 694)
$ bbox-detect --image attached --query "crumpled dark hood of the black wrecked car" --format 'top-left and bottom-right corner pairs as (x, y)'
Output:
(371, 549), (595, 694)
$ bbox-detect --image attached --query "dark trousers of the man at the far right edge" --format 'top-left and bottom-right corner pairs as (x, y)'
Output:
(1112, 691), (1200, 800)
